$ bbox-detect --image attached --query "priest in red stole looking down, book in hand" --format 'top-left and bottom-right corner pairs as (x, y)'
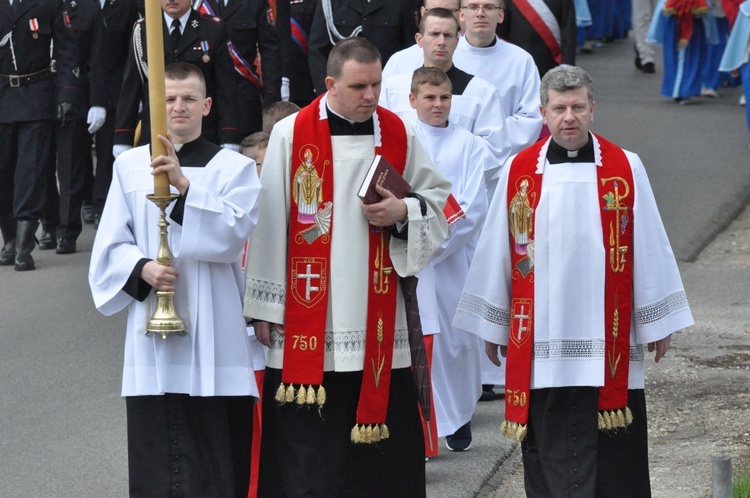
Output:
(245, 38), (450, 497)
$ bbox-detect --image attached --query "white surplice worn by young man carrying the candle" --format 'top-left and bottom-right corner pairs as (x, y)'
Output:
(89, 146), (260, 396)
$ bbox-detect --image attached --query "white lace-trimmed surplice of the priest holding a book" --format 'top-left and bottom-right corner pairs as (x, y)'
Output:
(245, 97), (450, 372)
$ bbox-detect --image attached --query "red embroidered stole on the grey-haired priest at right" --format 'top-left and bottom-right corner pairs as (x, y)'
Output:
(501, 135), (635, 440)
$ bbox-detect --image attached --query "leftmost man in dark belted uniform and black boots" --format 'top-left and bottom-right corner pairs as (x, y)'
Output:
(0, 0), (80, 271)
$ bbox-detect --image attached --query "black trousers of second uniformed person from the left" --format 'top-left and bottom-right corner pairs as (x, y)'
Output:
(57, 119), (92, 241)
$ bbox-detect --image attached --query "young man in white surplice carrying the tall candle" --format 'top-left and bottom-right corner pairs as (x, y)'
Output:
(89, 63), (260, 497)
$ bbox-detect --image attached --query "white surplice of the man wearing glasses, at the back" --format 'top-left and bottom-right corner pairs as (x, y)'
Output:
(453, 36), (542, 163)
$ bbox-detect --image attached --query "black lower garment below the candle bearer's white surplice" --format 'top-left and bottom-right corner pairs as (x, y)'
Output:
(125, 394), (253, 498)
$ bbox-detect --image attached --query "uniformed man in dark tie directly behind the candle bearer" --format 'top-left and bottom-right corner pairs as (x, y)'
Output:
(112, 0), (242, 157)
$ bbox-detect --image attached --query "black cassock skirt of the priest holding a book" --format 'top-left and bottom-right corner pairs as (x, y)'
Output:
(258, 368), (426, 498)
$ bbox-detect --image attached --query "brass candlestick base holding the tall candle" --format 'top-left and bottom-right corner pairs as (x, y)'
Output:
(146, 194), (186, 339)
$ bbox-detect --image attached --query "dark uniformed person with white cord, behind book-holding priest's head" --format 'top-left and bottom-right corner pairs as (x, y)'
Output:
(310, 0), (417, 95)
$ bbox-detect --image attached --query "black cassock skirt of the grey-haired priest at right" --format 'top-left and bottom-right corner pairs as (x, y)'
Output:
(521, 387), (651, 498)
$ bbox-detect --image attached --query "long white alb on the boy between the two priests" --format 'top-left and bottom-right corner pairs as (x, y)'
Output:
(414, 120), (495, 436)
